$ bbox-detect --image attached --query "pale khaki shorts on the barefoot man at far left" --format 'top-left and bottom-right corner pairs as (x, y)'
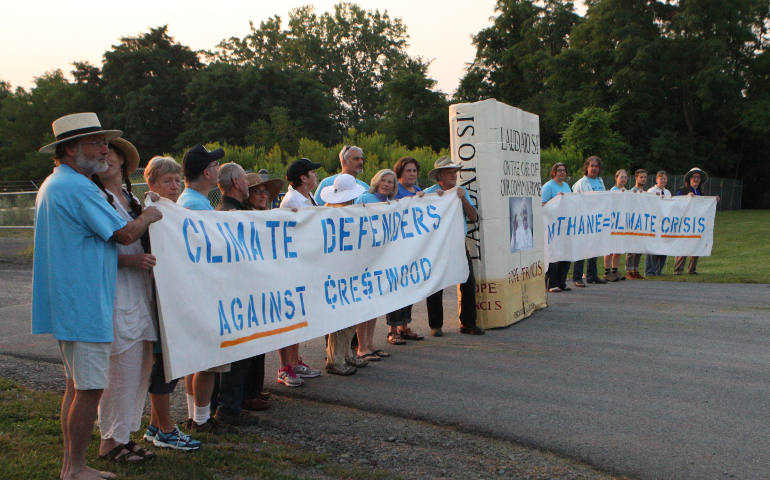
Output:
(59, 340), (112, 390)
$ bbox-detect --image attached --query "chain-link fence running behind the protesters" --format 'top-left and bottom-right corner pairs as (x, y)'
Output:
(0, 169), (743, 229)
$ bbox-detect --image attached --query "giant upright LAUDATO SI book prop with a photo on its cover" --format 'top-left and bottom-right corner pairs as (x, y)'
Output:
(449, 99), (546, 328)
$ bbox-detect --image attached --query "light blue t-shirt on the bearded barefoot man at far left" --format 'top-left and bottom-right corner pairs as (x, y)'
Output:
(32, 165), (126, 342)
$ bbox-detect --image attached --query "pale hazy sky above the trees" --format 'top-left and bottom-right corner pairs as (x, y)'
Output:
(0, 0), (512, 94)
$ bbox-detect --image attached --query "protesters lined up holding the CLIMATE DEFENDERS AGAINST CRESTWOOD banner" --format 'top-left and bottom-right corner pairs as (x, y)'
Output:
(32, 113), (484, 479)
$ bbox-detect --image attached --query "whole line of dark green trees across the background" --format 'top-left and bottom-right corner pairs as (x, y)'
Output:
(0, 0), (770, 208)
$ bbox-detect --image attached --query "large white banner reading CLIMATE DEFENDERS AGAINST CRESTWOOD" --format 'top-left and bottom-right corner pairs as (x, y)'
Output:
(150, 194), (468, 379)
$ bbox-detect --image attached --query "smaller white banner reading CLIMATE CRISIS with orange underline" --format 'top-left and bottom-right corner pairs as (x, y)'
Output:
(543, 192), (716, 262)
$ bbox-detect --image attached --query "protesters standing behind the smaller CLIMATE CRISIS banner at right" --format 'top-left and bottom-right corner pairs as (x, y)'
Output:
(542, 155), (708, 293)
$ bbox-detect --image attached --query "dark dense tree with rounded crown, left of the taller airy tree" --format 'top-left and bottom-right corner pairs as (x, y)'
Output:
(102, 25), (201, 157)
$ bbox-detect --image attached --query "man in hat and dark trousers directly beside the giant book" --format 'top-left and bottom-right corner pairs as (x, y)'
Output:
(425, 157), (484, 337)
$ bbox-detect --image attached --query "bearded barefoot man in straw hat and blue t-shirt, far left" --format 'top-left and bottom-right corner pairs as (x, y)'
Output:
(32, 113), (161, 479)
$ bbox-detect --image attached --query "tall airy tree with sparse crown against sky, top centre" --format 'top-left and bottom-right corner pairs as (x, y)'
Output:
(210, 3), (409, 129)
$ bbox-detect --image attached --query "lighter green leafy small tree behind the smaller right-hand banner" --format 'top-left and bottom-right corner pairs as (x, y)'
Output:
(562, 107), (628, 172)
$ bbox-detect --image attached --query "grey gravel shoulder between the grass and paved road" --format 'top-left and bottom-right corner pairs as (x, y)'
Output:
(0, 235), (627, 479)
